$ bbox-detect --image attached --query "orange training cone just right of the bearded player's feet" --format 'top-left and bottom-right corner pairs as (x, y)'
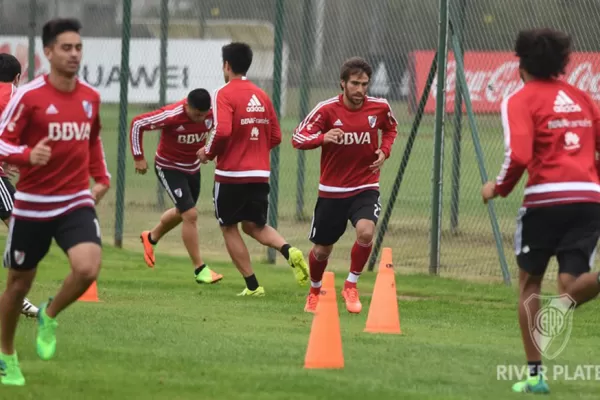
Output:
(364, 247), (402, 334)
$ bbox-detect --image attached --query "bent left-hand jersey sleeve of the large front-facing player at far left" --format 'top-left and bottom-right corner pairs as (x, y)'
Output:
(0, 95), (32, 165)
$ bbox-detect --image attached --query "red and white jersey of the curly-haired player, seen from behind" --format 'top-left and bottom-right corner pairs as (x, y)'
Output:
(496, 80), (600, 207)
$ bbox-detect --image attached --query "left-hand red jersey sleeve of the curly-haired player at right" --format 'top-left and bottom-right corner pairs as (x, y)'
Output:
(496, 93), (534, 197)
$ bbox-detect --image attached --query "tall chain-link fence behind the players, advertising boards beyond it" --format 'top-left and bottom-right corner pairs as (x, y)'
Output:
(0, 0), (600, 279)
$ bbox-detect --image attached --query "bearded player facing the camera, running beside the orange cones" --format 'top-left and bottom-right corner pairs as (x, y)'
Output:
(292, 57), (397, 313)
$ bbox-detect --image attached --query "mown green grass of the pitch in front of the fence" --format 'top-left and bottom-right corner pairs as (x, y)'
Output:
(0, 236), (600, 400)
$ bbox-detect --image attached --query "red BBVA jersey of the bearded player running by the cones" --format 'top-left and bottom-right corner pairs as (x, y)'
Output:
(292, 94), (398, 198)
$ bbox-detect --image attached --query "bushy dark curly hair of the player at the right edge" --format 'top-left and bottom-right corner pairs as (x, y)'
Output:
(515, 28), (571, 79)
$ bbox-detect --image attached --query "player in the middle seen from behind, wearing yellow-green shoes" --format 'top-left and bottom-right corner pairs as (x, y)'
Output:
(198, 42), (308, 296)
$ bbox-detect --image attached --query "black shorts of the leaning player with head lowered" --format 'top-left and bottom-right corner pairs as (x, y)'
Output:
(154, 165), (200, 213)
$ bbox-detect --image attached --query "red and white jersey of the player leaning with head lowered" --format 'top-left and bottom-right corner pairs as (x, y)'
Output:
(129, 99), (213, 174)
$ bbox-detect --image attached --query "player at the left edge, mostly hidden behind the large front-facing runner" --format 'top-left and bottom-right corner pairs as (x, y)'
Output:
(0, 53), (39, 317)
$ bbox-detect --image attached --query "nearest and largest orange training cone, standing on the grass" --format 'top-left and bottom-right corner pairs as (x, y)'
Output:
(304, 271), (344, 368)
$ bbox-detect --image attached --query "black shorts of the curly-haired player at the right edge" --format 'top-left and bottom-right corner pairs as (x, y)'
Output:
(515, 203), (600, 276)
